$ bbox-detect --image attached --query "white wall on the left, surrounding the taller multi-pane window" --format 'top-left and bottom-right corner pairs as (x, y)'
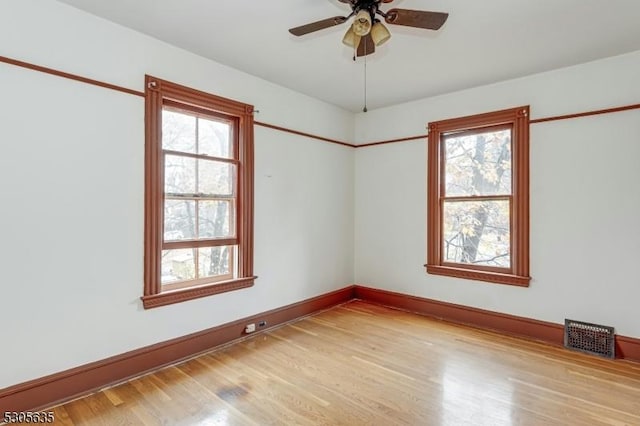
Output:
(0, 0), (354, 388)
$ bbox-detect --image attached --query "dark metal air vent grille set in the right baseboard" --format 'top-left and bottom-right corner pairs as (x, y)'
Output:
(564, 319), (615, 358)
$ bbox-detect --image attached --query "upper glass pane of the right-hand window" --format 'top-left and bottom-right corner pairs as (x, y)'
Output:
(443, 129), (511, 197)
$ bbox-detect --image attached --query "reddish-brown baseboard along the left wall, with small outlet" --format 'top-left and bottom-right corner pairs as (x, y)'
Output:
(0, 286), (354, 413)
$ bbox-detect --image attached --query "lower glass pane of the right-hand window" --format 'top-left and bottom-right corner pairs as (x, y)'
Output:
(442, 200), (511, 268)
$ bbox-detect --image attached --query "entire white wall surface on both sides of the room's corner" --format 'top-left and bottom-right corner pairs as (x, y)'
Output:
(0, 0), (640, 388)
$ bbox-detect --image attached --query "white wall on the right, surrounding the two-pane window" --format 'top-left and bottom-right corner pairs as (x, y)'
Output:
(355, 52), (640, 337)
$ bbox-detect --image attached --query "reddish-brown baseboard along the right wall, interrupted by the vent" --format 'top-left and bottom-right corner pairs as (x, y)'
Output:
(355, 286), (640, 362)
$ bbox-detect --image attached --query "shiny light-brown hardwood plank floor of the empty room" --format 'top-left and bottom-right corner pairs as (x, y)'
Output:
(47, 301), (640, 426)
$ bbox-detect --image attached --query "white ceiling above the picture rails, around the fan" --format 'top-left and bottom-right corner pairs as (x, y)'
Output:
(59, 0), (640, 111)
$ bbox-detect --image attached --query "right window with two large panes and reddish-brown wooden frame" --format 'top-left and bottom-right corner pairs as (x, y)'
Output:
(425, 106), (530, 286)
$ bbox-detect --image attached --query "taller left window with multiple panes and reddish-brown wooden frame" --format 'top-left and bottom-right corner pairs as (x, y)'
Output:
(142, 76), (255, 308)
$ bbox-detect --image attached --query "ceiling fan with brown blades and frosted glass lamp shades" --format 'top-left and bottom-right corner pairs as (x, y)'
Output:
(289, 0), (449, 56)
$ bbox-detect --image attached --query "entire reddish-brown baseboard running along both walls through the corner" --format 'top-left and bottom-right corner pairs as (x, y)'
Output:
(5, 286), (640, 413)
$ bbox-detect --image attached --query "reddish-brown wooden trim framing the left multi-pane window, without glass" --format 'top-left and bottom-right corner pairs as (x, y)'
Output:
(141, 75), (256, 309)
